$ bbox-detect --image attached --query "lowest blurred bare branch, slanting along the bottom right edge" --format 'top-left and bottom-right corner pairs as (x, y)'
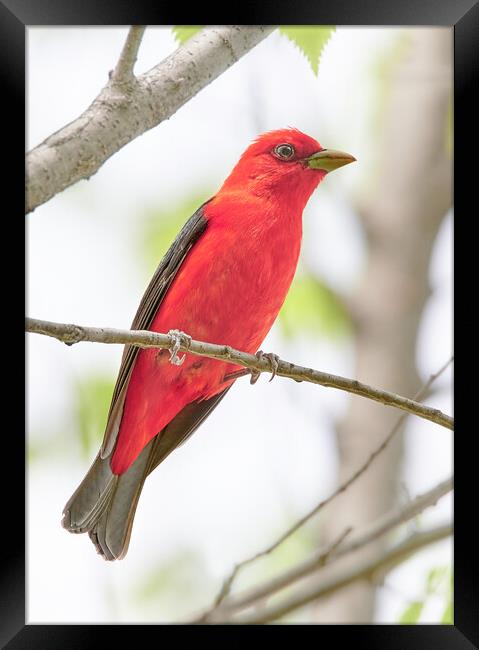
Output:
(226, 524), (453, 623)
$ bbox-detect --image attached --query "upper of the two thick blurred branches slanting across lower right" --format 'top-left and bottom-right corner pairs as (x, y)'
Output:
(199, 478), (453, 622)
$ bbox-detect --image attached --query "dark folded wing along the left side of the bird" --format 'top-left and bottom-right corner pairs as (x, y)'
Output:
(100, 201), (208, 458)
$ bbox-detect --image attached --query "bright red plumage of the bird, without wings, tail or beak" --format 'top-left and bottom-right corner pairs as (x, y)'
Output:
(111, 129), (325, 474)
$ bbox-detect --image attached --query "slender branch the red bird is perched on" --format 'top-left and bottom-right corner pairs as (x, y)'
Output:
(25, 318), (454, 429)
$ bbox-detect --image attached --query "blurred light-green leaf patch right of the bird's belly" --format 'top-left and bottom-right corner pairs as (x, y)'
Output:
(278, 274), (350, 338)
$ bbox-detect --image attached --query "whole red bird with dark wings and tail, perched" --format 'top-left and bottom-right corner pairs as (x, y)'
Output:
(62, 129), (355, 560)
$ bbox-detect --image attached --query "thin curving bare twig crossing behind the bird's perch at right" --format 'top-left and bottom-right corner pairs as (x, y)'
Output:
(202, 357), (454, 611)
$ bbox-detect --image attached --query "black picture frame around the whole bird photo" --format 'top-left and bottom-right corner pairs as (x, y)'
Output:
(9, 0), (479, 650)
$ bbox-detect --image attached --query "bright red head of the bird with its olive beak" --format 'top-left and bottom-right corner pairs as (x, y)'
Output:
(221, 128), (356, 209)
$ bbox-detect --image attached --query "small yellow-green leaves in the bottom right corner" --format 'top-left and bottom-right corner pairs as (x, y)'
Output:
(399, 565), (453, 625)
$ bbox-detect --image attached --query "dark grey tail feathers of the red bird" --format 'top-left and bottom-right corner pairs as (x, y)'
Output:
(62, 438), (155, 560)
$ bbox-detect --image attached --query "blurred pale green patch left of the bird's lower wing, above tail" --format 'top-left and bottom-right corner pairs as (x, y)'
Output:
(72, 373), (115, 459)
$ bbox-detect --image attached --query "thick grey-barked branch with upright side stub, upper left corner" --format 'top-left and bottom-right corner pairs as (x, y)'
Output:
(25, 26), (274, 213)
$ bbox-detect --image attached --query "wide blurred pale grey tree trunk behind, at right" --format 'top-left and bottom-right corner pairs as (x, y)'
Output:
(313, 28), (452, 623)
